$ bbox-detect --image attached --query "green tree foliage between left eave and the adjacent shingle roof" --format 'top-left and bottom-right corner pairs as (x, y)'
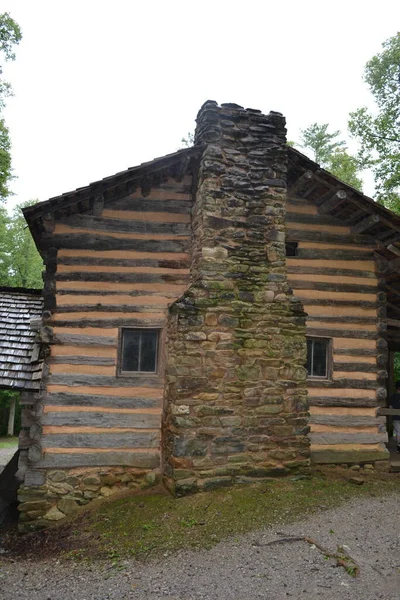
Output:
(0, 201), (43, 288)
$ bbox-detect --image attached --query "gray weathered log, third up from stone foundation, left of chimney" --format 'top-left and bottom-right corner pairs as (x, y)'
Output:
(41, 410), (161, 429)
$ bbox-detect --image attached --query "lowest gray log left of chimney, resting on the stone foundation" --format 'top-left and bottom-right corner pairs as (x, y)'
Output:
(37, 449), (160, 469)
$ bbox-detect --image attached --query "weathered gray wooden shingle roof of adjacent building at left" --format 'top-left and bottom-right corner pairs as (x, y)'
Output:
(0, 287), (43, 391)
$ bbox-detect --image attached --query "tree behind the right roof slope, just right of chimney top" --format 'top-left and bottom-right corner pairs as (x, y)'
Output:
(301, 123), (362, 190)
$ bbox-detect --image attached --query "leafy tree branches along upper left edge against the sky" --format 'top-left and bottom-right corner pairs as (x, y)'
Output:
(0, 13), (22, 201)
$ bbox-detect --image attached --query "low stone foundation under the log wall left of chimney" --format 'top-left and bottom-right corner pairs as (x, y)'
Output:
(18, 467), (160, 532)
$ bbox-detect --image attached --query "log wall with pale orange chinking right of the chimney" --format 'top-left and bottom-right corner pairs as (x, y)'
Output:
(286, 197), (387, 463)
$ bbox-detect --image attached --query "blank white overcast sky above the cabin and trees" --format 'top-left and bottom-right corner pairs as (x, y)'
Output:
(0, 0), (400, 209)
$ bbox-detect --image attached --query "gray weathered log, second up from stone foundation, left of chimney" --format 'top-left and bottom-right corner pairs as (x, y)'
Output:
(42, 431), (160, 449)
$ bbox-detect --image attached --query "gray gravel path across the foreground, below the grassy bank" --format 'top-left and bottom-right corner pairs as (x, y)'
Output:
(0, 496), (400, 600)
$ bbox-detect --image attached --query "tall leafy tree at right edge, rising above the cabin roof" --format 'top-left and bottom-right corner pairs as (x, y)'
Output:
(349, 33), (400, 212)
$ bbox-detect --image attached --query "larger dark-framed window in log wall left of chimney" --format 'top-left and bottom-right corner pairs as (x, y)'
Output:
(119, 329), (159, 375)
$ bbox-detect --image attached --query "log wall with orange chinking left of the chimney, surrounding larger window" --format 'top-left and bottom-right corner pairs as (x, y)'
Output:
(17, 176), (192, 521)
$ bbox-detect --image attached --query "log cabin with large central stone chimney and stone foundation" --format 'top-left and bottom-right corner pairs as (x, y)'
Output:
(3, 101), (400, 530)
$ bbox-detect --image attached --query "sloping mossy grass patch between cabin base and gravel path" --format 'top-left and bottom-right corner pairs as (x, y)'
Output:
(5, 470), (400, 565)
